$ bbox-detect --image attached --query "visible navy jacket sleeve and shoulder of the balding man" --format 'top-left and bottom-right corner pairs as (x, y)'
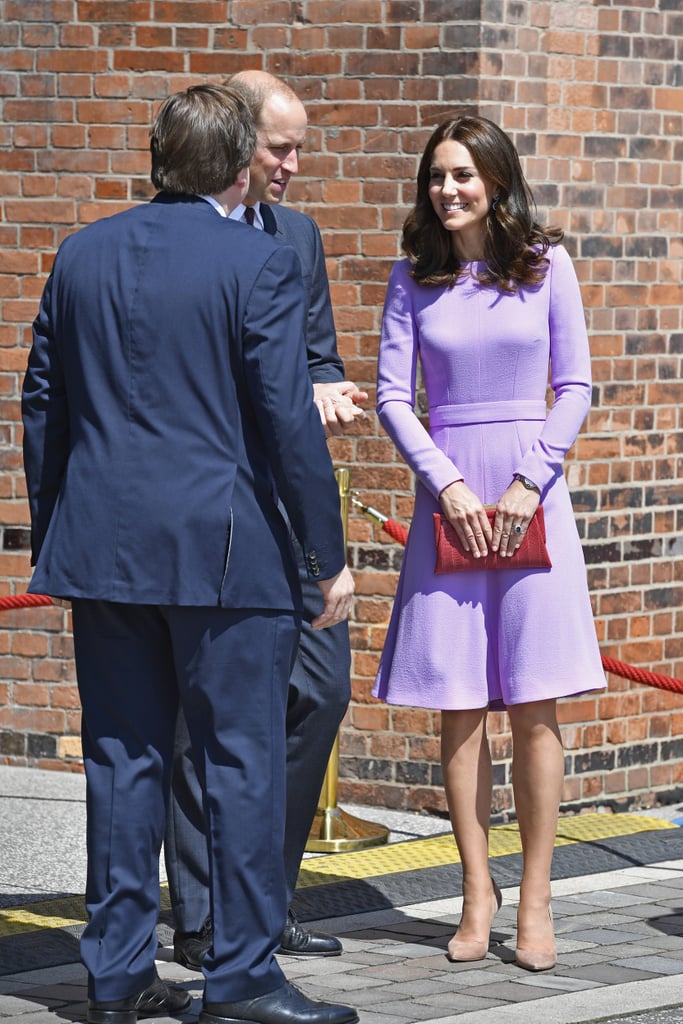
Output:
(259, 203), (344, 384)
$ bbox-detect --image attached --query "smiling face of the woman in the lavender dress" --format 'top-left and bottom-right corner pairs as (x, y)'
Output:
(429, 139), (494, 260)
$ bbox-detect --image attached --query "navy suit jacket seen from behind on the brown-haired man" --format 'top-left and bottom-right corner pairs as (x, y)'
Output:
(23, 193), (345, 609)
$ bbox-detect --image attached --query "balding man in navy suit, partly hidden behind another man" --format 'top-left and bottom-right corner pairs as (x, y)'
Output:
(165, 71), (367, 970)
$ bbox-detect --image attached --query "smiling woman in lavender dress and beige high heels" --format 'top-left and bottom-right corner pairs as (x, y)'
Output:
(373, 117), (605, 971)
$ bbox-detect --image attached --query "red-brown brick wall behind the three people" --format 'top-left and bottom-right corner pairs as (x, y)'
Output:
(0, 0), (683, 813)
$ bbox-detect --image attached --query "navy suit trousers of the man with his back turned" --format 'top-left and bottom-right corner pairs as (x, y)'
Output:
(73, 600), (299, 1002)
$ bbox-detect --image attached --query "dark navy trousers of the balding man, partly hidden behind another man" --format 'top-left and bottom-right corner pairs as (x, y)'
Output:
(164, 543), (351, 932)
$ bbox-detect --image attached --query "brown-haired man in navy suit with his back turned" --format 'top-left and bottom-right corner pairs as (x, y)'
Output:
(23, 86), (357, 1024)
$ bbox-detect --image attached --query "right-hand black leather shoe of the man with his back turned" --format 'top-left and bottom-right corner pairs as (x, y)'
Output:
(199, 982), (358, 1024)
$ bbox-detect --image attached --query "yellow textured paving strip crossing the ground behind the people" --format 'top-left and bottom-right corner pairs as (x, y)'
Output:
(0, 814), (678, 938)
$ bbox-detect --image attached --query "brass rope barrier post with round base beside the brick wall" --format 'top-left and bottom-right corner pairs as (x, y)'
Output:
(306, 469), (389, 853)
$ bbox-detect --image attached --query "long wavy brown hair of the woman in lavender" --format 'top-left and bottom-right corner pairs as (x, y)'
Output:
(401, 115), (563, 292)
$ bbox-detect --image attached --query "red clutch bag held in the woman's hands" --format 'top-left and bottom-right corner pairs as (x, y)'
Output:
(434, 505), (553, 572)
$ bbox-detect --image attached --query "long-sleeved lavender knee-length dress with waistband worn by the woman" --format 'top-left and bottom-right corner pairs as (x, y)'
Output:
(373, 246), (605, 710)
